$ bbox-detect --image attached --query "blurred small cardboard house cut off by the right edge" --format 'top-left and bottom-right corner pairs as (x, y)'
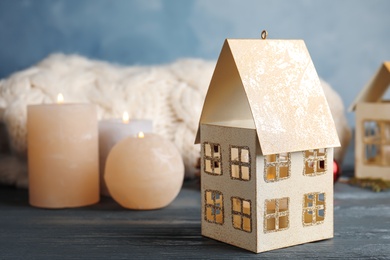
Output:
(350, 62), (390, 180)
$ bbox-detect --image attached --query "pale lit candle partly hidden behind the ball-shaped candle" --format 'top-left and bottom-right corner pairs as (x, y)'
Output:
(99, 112), (153, 196)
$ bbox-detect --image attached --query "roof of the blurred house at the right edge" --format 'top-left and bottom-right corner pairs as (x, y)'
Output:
(349, 61), (390, 111)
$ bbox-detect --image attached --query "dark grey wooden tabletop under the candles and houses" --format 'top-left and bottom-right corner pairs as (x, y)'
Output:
(0, 180), (390, 259)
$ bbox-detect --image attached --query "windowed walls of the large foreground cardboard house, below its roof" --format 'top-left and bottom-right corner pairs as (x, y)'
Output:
(201, 124), (333, 252)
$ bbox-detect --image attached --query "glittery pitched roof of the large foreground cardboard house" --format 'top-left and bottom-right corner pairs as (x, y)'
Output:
(195, 39), (340, 154)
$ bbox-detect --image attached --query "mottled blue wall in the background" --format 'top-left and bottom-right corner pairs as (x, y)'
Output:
(0, 0), (390, 128)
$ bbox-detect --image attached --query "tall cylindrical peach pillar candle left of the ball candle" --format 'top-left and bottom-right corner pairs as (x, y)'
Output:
(27, 101), (99, 208)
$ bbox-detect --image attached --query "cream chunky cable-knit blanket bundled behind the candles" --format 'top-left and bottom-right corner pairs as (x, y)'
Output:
(0, 54), (350, 187)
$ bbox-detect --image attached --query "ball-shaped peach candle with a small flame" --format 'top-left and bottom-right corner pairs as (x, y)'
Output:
(104, 133), (184, 210)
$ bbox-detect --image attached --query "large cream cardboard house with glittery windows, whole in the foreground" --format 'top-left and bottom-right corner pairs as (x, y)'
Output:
(195, 39), (339, 252)
